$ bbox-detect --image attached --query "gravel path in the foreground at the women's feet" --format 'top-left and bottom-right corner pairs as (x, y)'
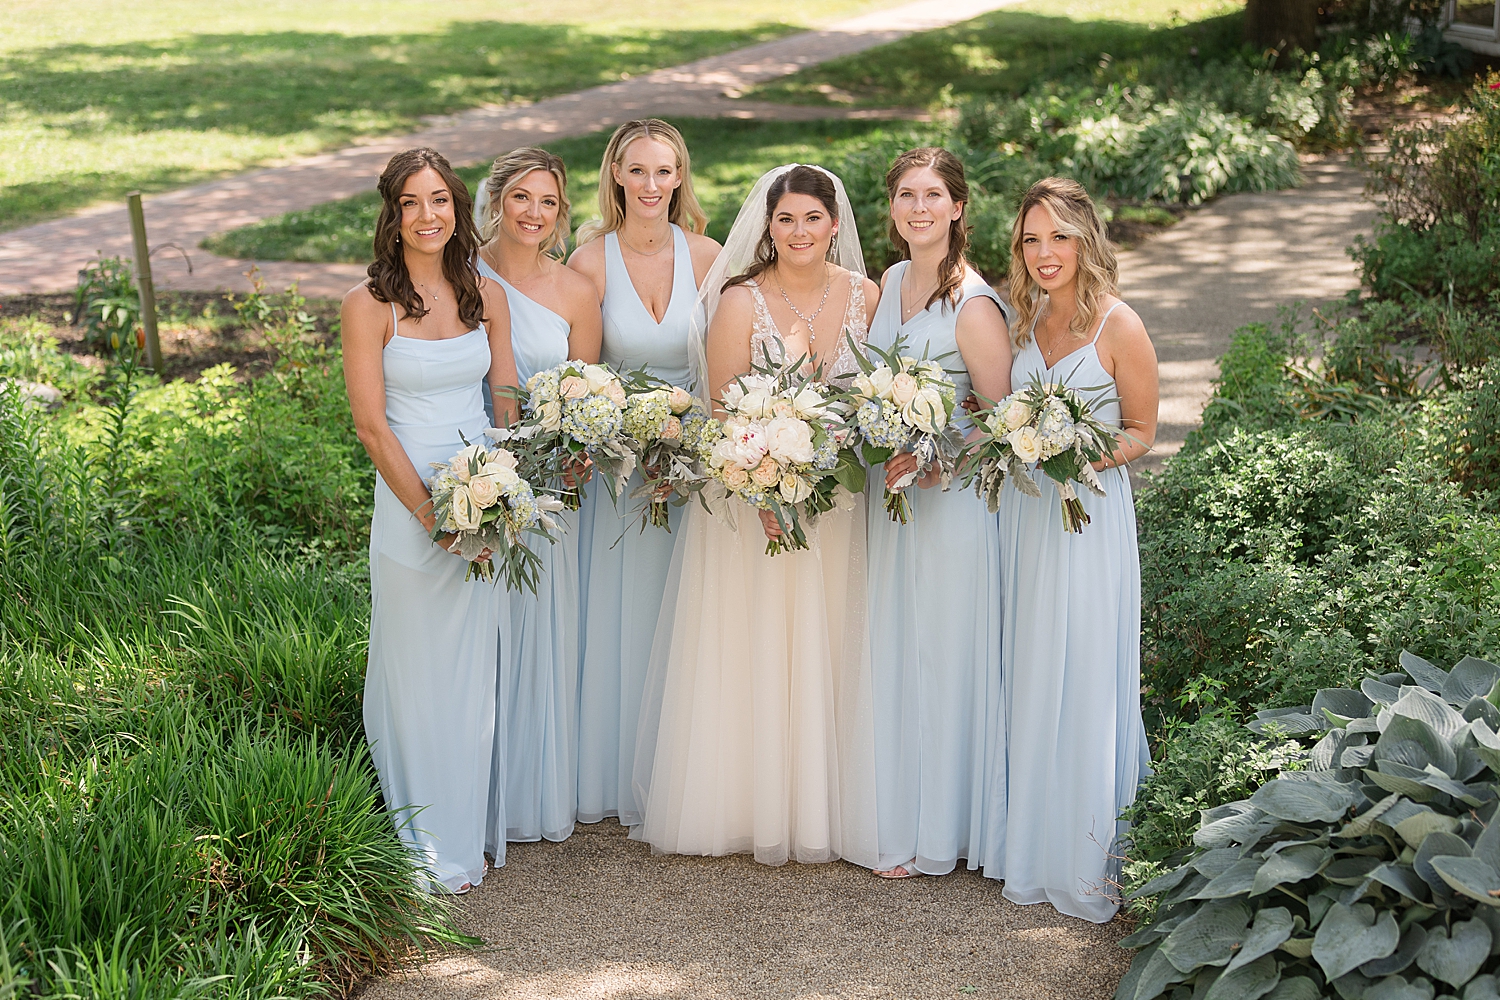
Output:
(363, 820), (1130, 1000)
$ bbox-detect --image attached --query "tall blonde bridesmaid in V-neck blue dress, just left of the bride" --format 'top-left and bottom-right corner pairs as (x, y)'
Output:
(569, 118), (720, 826)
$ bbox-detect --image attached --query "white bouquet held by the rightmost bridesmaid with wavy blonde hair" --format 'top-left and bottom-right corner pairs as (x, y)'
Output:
(965, 375), (1115, 532)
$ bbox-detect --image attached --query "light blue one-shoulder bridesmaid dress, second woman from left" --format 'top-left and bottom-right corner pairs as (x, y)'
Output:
(479, 259), (578, 865)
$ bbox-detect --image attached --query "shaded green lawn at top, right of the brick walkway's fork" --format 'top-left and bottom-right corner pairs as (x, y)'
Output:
(746, 0), (1245, 106)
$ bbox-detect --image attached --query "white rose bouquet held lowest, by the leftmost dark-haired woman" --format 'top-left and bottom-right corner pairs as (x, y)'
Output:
(428, 427), (563, 594)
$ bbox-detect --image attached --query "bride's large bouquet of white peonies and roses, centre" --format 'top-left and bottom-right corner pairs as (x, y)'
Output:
(707, 350), (864, 555)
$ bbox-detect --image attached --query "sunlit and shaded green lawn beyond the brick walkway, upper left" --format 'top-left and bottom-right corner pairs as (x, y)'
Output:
(0, 0), (894, 229)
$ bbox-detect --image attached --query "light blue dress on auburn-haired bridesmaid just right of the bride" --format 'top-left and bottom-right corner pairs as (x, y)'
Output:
(867, 261), (1008, 876)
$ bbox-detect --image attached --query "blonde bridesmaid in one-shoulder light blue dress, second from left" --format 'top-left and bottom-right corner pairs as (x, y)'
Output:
(479, 147), (602, 865)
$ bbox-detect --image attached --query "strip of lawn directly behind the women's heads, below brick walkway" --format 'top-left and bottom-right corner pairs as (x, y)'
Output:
(206, 118), (900, 262)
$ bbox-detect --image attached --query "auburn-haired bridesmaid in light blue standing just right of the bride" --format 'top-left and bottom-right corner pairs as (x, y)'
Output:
(867, 148), (1011, 879)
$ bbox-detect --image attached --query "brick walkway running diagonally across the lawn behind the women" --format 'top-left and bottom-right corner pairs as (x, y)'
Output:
(0, 0), (1017, 297)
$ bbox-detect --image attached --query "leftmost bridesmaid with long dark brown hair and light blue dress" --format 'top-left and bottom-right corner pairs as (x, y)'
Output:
(342, 148), (516, 892)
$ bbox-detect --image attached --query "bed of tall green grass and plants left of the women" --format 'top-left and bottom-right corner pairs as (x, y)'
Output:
(0, 314), (462, 999)
